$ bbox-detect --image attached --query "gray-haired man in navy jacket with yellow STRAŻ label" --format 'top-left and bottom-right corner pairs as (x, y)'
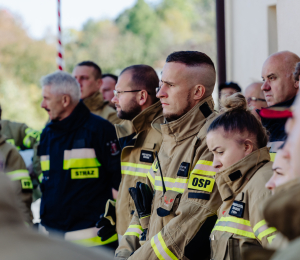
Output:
(38, 71), (121, 248)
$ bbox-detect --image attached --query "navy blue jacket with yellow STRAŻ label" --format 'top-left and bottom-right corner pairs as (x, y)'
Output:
(38, 101), (121, 232)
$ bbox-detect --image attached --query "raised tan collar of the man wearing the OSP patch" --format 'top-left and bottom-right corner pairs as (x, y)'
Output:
(159, 96), (214, 142)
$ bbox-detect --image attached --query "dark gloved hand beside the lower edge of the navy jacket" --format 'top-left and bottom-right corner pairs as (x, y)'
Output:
(96, 200), (116, 241)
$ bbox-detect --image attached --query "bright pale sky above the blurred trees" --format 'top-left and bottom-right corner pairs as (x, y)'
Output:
(0, 0), (159, 39)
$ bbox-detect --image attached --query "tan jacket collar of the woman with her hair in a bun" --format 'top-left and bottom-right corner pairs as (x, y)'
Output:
(216, 147), (270, 201)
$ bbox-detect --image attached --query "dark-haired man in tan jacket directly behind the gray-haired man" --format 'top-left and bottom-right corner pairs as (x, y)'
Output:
(72, 61), (121, 124)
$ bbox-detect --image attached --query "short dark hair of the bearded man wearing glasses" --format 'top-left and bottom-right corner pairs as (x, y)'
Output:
(120, 64), (159, 103)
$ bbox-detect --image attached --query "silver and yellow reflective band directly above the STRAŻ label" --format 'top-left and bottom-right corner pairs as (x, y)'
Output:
(63, 148), (101, 170)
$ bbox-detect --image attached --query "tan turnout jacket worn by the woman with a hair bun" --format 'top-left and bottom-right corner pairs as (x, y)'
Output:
(210, 147), (276, 260)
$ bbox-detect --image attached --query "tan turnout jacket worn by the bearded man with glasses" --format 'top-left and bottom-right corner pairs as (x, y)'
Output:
(115, 101), (162, 236)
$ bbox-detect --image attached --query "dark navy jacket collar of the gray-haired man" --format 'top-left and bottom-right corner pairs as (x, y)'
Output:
(47, 100), (90, 132)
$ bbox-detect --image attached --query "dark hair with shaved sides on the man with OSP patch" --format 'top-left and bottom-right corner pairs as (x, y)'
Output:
(166, 51), (216, 97)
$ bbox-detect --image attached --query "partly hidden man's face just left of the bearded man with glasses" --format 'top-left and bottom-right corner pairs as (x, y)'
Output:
(100, 73), (118, 109)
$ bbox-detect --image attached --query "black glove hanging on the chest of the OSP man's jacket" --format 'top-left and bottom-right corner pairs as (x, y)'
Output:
(129, 182), (153, 218)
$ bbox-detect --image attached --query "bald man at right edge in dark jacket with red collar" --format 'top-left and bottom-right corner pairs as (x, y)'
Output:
(261, 51), (300, 161)
